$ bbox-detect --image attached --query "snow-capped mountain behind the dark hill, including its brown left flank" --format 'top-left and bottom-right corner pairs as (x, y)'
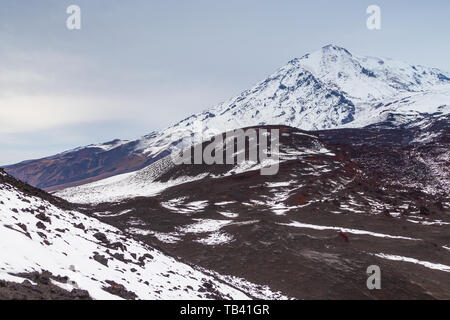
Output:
(6, 45), (450, 190)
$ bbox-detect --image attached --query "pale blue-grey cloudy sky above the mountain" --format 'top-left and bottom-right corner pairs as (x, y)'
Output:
(0, 0), (450, 165)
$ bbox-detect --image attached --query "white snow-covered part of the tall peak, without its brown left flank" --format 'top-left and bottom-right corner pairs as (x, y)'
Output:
(135, 45), (450, 156)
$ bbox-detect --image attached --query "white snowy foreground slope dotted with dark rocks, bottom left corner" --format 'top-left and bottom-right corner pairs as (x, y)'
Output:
(0, 171), (283, 299)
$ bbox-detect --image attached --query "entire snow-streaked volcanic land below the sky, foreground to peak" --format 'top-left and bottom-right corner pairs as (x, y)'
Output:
(0, 45), (450, 299)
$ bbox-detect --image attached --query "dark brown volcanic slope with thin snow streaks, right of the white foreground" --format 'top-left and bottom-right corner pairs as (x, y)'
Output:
(61, 122), (450, 299)
